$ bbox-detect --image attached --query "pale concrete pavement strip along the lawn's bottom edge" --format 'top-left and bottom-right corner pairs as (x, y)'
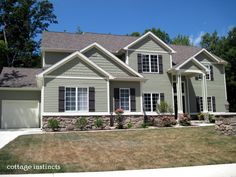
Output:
(1, 163), (236, 177)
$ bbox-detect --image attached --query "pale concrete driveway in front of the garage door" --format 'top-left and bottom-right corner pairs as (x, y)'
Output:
(0, 128), (43, 149)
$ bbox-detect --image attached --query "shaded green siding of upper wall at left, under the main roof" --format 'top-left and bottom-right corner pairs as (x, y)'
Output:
(45, 52), (71, 65)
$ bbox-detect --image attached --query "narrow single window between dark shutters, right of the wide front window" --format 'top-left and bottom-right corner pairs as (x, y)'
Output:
(120, 88), (130, 111)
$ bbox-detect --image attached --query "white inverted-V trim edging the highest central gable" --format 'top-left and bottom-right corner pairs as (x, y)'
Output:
(123, 31), (176, 53)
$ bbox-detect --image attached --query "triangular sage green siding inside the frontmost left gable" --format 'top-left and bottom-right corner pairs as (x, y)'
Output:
(48, 57), (102, 77)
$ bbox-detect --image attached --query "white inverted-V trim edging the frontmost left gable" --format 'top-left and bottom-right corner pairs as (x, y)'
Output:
(37, 51), (114, 79)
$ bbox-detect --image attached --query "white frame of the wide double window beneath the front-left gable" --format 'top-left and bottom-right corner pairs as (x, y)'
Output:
(64, 86), (89, 113)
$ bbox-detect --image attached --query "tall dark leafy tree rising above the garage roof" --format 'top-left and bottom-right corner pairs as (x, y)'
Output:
(0, 0), (57, 67)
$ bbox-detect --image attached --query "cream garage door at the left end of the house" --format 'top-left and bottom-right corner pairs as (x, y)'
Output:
(1, 100), (39, 128)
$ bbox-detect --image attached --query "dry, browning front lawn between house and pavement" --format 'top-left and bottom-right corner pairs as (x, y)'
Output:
(0, 127), (236, 173)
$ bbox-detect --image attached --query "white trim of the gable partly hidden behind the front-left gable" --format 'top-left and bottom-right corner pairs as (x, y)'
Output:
(80, 42), (143, 78)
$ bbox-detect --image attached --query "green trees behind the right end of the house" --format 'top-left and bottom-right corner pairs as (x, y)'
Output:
(200, 27), (236, 112)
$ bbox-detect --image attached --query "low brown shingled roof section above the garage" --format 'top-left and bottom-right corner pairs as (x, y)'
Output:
(0, 67), (43, 88)
